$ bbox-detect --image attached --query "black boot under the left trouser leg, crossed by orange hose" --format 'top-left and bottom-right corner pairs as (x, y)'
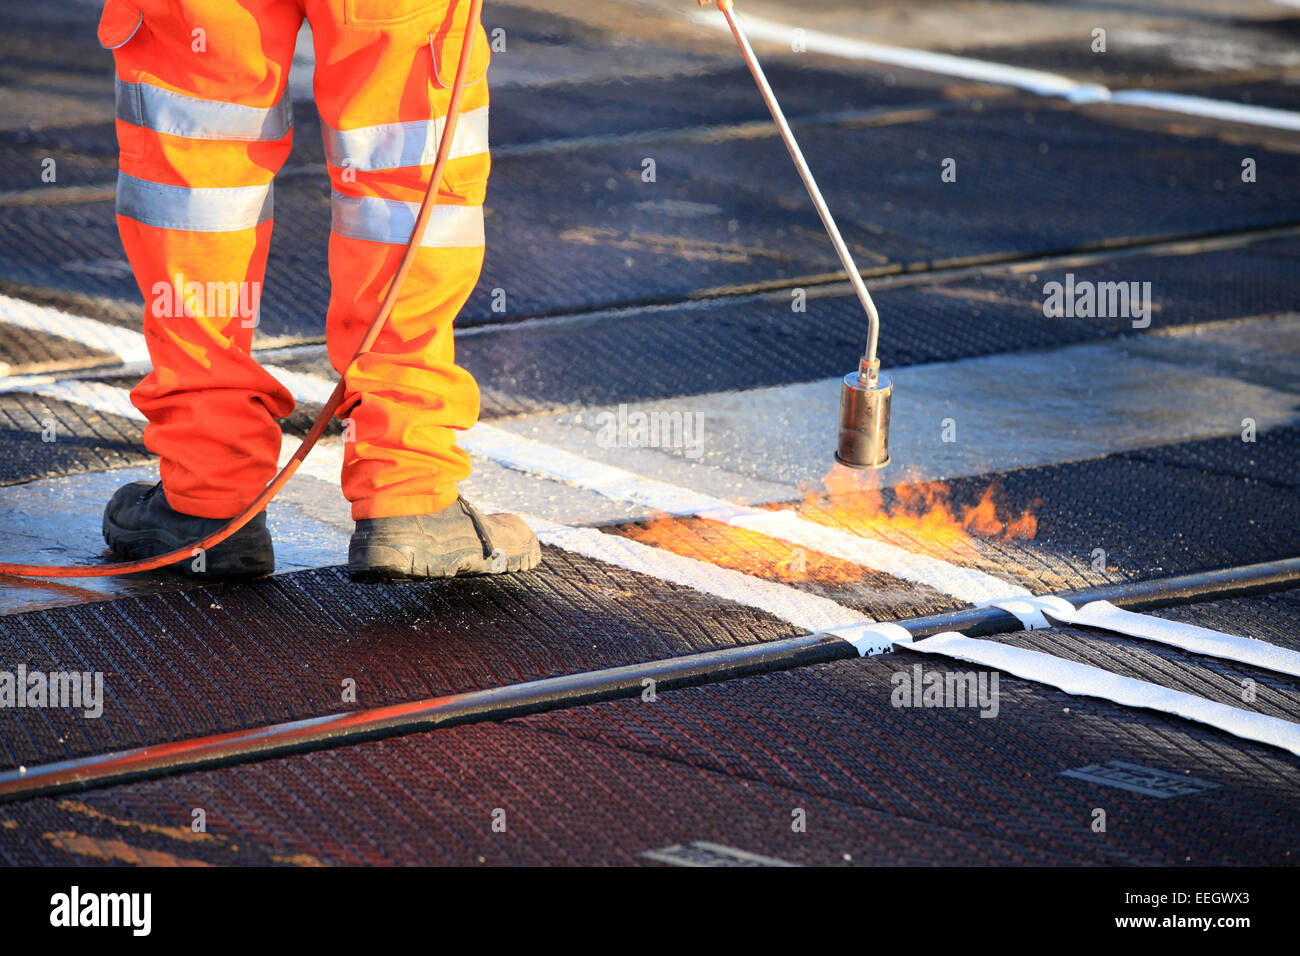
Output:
(104, 481), (276, 580)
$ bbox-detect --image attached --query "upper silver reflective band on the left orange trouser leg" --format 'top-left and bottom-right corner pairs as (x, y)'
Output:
(117, 79), (294, 142)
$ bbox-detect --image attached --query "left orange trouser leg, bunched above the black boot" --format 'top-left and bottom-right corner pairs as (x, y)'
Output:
(99, 0), (303, 518)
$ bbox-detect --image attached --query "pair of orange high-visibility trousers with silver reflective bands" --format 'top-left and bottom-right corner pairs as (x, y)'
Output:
(99, 0), (489, 519)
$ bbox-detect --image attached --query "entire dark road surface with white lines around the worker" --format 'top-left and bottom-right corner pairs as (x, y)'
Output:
(0, 0), (1300, 865)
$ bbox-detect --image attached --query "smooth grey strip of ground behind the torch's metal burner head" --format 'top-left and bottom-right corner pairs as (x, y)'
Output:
(488, 319), (1300, 502)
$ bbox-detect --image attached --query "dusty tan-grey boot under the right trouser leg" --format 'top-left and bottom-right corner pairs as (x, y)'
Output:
(347, 498), (542, 584)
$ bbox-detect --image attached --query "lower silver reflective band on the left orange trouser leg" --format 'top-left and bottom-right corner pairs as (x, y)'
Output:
(117, 173), (274, 233)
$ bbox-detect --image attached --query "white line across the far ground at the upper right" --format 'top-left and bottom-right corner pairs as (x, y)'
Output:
(689, 8), (1300, 130)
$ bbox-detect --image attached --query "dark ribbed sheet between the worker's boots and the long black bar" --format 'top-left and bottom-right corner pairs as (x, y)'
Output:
(0, 549), (821, 767)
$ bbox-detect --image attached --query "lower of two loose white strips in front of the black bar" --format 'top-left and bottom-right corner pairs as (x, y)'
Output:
(906, 631), (1300, 756)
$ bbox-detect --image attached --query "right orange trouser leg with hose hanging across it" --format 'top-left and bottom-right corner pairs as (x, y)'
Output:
(307, 0), (489, 520)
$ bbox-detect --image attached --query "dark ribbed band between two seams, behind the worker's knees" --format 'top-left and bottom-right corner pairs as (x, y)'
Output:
(0, 100), (1300, 341)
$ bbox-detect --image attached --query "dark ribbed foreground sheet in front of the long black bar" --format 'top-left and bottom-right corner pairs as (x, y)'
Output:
(0, 592), (1300, 865)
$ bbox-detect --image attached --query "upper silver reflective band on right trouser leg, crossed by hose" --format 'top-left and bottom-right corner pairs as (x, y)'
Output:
(321, 107), (488, 170)
